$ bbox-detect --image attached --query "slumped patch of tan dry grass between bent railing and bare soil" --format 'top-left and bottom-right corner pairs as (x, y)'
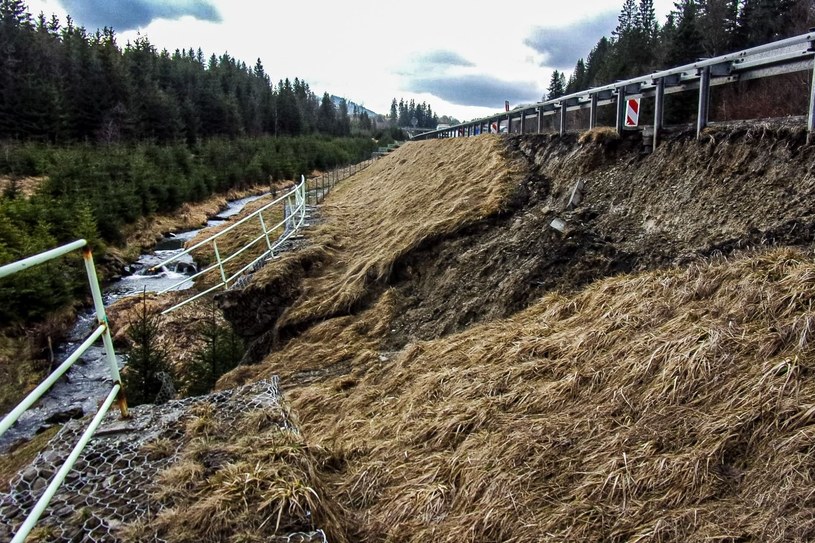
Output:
(255, 136), (521, 325)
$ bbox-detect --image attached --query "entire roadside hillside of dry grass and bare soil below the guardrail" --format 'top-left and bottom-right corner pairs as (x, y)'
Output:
(6, 125), (815, 542)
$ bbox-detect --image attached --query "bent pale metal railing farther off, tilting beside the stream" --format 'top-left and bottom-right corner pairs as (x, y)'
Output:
(153, 175), (306, 315)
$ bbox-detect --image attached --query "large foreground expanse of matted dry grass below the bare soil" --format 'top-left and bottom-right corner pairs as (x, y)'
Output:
(256, 250), (815, 542)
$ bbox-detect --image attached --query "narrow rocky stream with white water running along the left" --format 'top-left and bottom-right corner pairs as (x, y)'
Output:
(0, 195), (265, 453)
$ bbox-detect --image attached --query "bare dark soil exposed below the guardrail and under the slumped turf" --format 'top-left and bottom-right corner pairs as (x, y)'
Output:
(226, 125), (815, 360)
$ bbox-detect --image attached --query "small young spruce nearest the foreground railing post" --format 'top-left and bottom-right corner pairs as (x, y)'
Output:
(122, 297), (170, 406)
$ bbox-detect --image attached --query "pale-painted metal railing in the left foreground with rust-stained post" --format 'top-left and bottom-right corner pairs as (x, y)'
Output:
(0, 239), (129, 543)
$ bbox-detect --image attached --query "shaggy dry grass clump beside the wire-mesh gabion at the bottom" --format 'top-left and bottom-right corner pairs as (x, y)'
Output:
(143, 400), (345, 543)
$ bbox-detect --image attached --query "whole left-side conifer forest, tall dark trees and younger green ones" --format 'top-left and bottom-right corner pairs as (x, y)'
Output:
(0, 0), (382, 322)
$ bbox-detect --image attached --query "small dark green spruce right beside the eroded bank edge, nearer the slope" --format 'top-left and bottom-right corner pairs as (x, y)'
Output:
(184, 307), (244, 396)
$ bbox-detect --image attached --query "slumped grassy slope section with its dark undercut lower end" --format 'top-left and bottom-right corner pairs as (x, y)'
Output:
(222, 137), (524, 354)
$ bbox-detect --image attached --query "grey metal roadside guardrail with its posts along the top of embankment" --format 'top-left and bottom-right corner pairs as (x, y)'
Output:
(414, 32), (815, 146)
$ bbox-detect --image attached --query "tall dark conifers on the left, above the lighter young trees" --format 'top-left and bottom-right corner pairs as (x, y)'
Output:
(0, 0), (382, 143)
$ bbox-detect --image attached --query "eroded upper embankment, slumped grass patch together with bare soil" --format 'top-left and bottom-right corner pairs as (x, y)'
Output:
(223, 127), (815, 372)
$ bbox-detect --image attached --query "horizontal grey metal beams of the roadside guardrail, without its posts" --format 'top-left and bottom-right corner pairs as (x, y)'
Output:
(414, 32), (815, 140)
